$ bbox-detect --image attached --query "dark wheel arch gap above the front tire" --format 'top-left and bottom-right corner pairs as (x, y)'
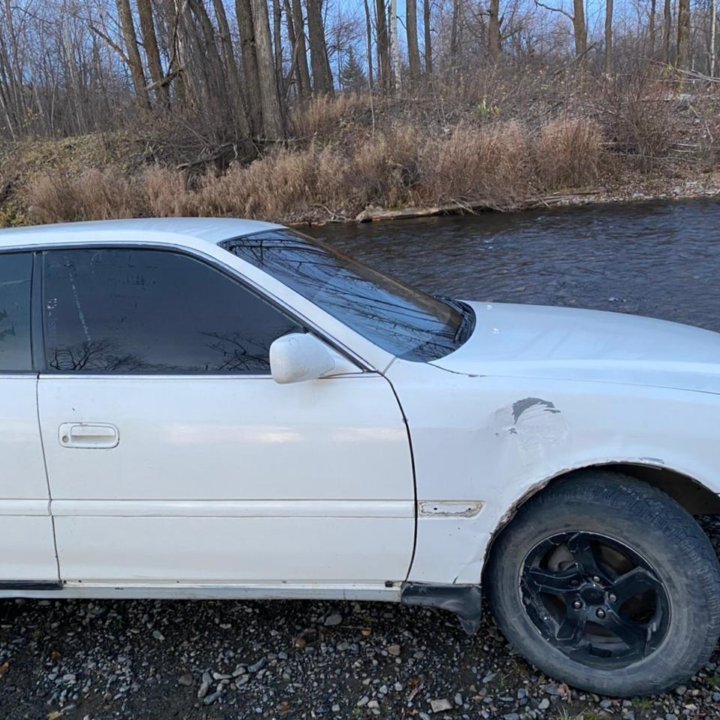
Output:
(483, 462), (720, 573)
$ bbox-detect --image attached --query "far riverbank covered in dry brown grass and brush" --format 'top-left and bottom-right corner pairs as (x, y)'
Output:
(0, 79), (720, 226)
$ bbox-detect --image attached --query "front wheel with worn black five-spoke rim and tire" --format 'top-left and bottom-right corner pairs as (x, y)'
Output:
(485, 470), (720, 697)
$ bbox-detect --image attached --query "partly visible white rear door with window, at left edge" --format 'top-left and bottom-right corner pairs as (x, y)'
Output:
(0, 252), (58, 591)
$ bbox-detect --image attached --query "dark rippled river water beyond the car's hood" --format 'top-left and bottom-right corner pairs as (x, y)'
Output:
(310, 200), (720, 331)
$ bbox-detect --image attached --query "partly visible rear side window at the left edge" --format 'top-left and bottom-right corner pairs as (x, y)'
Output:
(0, 253), (32, 372)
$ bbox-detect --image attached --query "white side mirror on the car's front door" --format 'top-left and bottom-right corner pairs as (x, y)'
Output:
(270, 333), (335, 384)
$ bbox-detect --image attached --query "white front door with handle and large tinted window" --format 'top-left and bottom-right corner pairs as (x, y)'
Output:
(39, 247), (414, 585)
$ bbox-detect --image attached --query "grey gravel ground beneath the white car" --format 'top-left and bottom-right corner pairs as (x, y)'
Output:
(0, 536), (720, 720)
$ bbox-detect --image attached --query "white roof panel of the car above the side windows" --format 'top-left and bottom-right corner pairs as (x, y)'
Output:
(0, 218), (282, 248)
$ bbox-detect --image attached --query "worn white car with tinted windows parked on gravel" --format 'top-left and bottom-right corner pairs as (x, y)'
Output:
(0, 219), (720, 696)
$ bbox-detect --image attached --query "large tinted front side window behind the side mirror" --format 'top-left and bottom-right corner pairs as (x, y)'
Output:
(43, 249), (300, 374)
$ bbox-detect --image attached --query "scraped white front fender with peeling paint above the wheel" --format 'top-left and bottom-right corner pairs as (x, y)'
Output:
(388, 363), (720, 584)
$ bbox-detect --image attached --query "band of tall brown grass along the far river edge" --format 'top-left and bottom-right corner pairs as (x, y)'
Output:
(26, 115), (603, 222)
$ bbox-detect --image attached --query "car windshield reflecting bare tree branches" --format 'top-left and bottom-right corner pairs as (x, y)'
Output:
(221, 229), (474, 362)
